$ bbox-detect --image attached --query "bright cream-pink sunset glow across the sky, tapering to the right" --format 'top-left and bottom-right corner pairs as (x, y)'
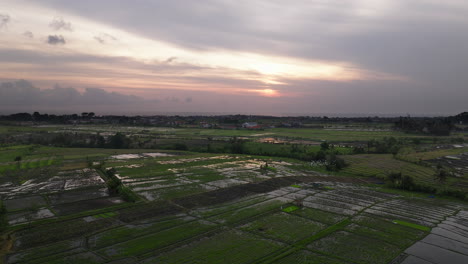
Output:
(0, 0), (404, 97)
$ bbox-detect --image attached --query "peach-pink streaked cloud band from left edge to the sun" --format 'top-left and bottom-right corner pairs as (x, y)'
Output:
(0, 48), (274, 93)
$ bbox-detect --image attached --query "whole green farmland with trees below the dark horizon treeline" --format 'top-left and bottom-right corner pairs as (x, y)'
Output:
(0, 121), (468, 264)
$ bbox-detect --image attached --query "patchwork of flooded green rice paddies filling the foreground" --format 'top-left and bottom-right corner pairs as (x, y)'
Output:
(0, 145), (468, 264)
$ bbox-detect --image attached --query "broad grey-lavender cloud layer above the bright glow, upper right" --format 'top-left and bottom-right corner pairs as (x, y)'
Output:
(33, 0), (468, 83)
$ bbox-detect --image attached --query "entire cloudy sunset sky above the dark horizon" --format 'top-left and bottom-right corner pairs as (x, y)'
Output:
(0, 0), (468, 116)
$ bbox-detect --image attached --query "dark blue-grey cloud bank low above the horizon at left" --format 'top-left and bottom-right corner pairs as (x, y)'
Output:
(0, 80), (143, 106)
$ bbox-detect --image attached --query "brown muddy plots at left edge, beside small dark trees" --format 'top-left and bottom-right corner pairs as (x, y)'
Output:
(0, 168), (123, 225)
